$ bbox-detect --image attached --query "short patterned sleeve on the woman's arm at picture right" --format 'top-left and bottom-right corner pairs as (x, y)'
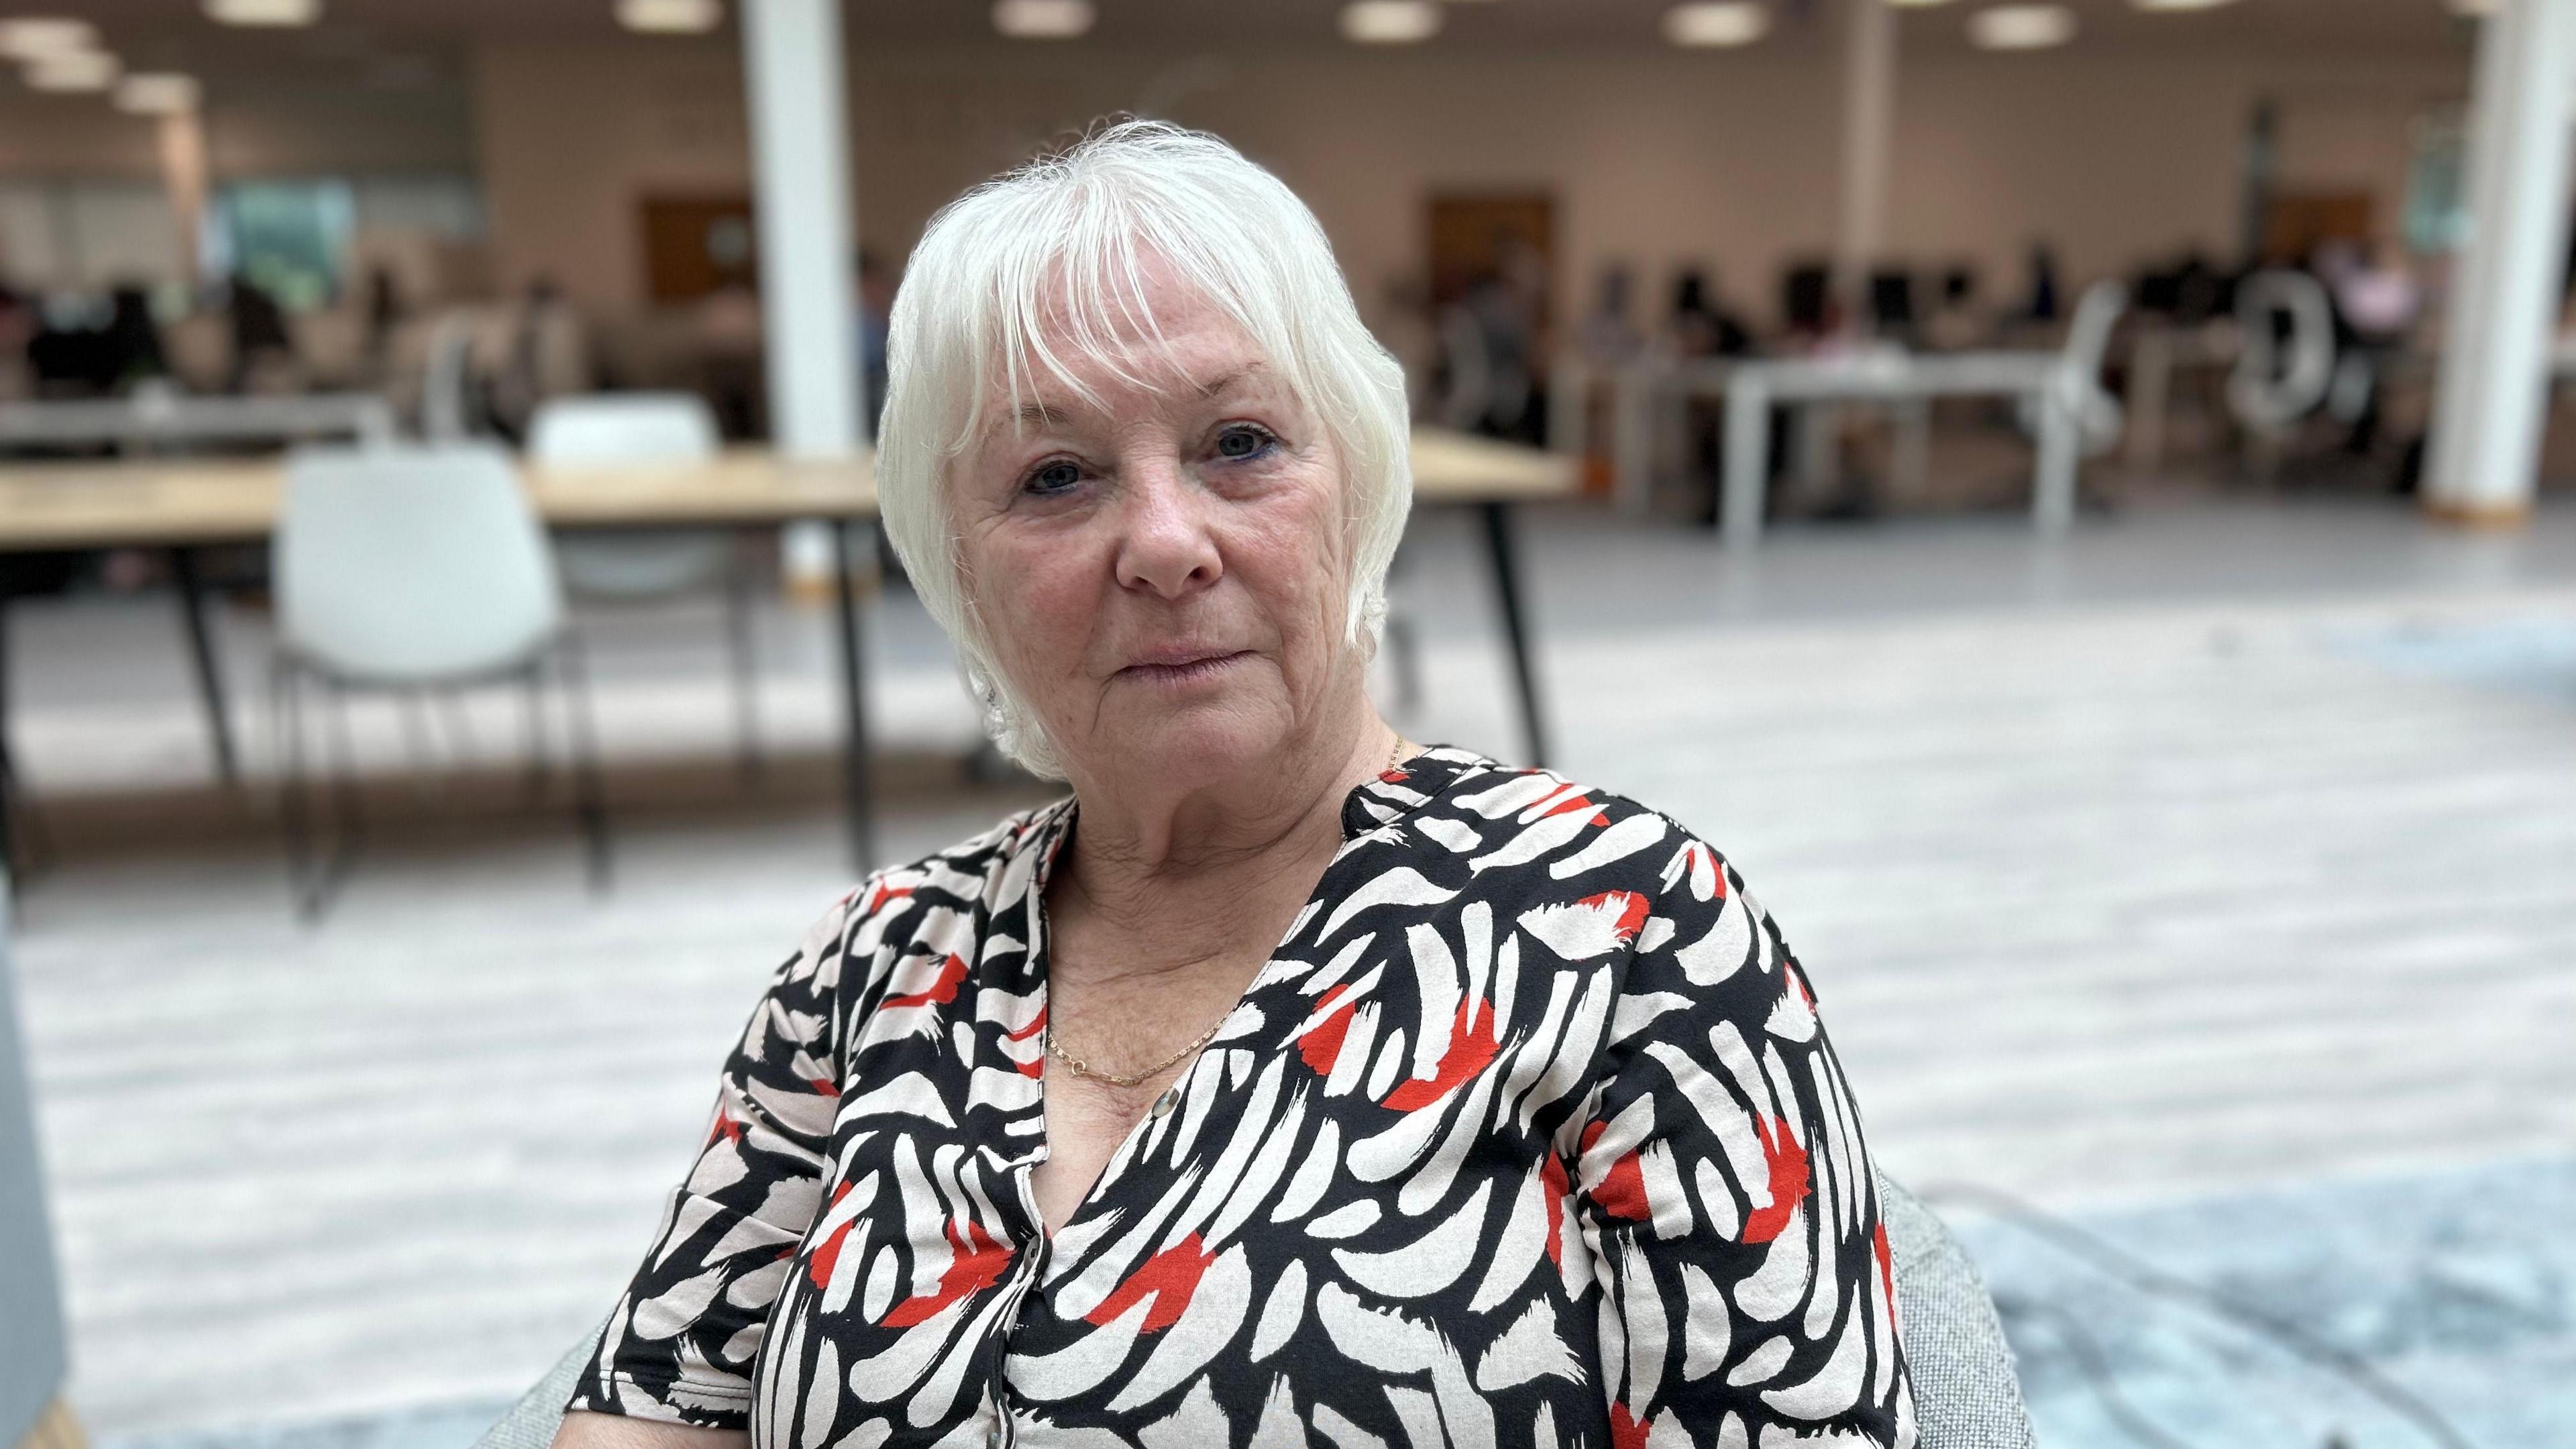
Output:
(1569, 828), (1914, 1449)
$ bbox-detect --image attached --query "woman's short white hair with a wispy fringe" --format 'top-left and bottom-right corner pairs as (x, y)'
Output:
(876, 121), (1414, 779)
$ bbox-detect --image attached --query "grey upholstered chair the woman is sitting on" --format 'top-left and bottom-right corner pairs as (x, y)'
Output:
(474, 1178), (2033, 1449)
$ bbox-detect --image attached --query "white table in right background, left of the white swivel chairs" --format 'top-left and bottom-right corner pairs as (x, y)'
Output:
(1721, 351), (2084, 549)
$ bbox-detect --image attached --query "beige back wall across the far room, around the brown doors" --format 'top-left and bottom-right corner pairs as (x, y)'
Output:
(474, 44), (2468, 325)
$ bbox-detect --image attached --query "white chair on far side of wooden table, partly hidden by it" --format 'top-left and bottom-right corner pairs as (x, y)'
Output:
(528, 392), (760, 776)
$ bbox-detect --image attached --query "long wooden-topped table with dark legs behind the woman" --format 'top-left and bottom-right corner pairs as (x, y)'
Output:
(0, 428), (1579, 869)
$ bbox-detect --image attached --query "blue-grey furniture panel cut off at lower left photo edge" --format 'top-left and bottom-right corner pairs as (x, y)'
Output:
(0, 864), (70, 1444)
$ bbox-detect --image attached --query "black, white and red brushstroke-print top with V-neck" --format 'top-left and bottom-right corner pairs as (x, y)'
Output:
(570, 748), (1914, 1449)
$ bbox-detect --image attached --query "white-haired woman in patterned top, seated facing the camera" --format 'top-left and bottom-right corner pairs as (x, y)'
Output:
(559, 123), (1914, 1449)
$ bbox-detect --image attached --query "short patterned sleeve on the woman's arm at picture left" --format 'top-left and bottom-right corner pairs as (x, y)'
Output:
(564, 887), (865, 1428)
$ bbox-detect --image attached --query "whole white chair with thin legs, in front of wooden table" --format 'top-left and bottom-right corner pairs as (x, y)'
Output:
(270, 443), (608, 918)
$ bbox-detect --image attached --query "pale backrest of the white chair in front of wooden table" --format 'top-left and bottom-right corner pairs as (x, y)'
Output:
(273, 443), (564, 684)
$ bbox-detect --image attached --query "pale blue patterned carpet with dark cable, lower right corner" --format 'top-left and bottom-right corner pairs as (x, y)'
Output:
(1927, 1158), (2576, 1449)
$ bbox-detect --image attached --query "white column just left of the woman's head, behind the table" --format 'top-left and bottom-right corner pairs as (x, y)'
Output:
(742, 0), (863, 580)
